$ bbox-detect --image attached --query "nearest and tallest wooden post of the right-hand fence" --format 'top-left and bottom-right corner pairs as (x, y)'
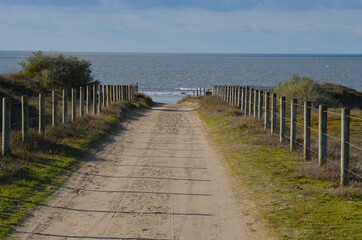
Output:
(341, 108), (350, 186)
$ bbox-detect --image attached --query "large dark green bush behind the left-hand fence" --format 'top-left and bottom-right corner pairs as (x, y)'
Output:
(19, 51), (94, 87)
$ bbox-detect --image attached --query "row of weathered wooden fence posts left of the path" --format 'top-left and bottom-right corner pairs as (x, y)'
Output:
(1, 83), (138, 155)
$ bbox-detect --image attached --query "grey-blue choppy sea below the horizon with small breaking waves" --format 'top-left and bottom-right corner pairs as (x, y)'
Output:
(0, 51), (362, 103)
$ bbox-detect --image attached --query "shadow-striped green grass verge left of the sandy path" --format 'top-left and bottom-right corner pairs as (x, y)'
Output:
(0, 96), (150, 239)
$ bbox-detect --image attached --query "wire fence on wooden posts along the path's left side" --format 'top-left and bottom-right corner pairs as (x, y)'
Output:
(0, 83), (138, 155)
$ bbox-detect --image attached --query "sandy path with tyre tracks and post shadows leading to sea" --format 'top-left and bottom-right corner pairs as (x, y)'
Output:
(12, 105), (249, 240)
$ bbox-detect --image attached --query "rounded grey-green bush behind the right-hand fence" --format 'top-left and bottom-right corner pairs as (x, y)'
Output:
(274, 75), (338, 107)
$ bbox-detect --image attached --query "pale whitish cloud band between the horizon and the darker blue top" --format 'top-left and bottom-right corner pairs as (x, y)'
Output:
(0, 4), (362, 52)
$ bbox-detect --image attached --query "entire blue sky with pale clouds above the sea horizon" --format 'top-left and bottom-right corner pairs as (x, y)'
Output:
(0, 0), (362, 54)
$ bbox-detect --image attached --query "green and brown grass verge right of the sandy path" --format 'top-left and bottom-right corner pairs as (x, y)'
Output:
(199, 97), (362, 239)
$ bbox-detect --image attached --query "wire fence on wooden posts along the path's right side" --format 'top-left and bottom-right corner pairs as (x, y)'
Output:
(212, 85), (362, 185)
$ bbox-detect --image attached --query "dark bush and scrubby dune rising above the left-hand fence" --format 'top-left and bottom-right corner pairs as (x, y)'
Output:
(0, 51), (98, 97)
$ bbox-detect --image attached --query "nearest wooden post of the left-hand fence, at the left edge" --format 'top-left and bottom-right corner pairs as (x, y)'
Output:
(2, 97), (11, 155)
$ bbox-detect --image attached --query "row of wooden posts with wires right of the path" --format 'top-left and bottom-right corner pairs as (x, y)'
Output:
(212, 85), (362, 186)
